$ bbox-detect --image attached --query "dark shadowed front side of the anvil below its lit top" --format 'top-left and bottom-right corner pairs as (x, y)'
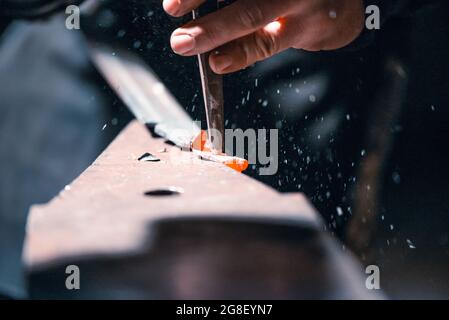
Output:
(29, 219), (370, 299)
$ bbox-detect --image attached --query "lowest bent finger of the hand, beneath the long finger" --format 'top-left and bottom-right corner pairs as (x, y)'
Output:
(209, 21), (291, 74)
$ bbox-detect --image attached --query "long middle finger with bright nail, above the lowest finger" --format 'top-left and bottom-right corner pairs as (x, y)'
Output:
(171, 0), (302, 56)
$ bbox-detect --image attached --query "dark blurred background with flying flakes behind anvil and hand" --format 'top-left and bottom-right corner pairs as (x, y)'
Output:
(0, 0), (449, 298)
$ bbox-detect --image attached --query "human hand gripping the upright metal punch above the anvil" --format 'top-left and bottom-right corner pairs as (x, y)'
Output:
(163, 0), (364, 74)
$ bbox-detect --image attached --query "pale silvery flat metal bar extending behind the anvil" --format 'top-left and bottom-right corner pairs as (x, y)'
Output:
(88, 41), (200, 149)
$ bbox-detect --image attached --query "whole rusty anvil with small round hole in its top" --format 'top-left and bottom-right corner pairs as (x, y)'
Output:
(24, 122), (373, 299)
